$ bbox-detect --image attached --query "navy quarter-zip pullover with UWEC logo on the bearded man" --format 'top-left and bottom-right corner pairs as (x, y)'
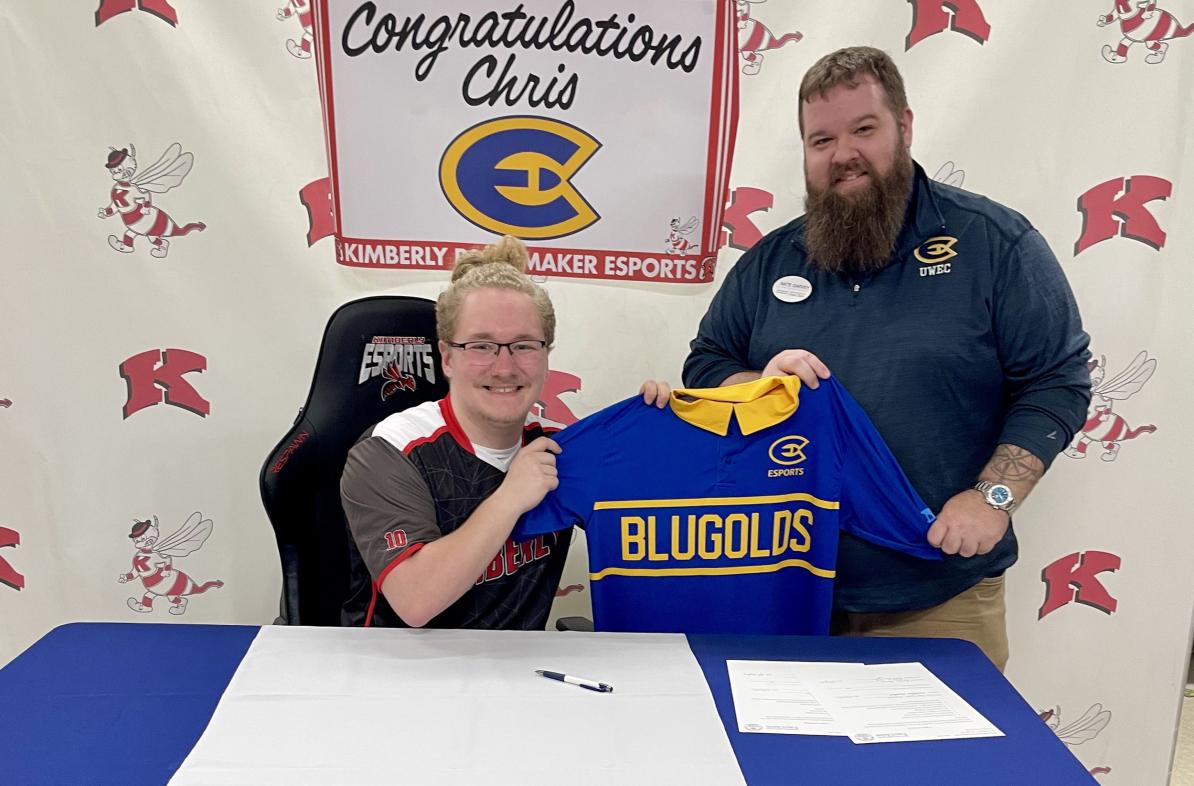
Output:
(684, 165), (1090, 612)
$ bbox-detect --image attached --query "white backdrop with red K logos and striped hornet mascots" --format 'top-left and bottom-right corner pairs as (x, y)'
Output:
(0, 0), (1194, 785)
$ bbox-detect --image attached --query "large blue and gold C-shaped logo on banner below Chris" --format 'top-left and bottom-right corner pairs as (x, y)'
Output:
(439, 117), (601, 240)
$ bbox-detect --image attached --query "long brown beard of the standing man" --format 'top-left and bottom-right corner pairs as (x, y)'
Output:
(805, 143), (912, 275)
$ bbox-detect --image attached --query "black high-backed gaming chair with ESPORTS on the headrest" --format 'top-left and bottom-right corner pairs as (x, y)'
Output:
(260, 296), (448, 625)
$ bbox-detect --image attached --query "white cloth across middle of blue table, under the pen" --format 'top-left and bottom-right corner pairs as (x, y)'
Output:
(168, 626), (744, 786)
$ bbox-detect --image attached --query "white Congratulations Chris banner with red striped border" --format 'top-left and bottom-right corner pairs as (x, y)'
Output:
(315, 0), (737, 283)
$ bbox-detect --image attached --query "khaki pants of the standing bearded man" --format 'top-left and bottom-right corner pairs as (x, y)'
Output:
(833, 576), (1008, 671)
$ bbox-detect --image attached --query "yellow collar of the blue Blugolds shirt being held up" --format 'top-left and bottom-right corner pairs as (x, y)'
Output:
(671, 376), (800, 436)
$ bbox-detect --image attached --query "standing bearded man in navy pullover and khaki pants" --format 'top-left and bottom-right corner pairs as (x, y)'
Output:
(684, 47), (1090, 669)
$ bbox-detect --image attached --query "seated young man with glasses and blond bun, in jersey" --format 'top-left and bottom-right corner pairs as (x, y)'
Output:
(340, 238), (670, 630)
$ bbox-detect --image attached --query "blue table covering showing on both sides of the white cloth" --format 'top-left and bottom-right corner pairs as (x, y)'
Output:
(0, 622), (1095, 786)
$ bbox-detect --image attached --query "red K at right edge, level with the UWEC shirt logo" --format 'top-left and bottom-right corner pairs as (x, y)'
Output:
(1073, 174), (1174, 257)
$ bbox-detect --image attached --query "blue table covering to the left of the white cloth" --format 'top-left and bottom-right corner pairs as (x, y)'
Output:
(0, 622), (260, 786)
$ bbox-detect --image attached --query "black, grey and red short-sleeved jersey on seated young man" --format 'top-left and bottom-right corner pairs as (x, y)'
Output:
(340, 398), (572, 630)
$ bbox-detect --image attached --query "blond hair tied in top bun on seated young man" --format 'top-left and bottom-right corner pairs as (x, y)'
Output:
(436, 235), (555, 348)
